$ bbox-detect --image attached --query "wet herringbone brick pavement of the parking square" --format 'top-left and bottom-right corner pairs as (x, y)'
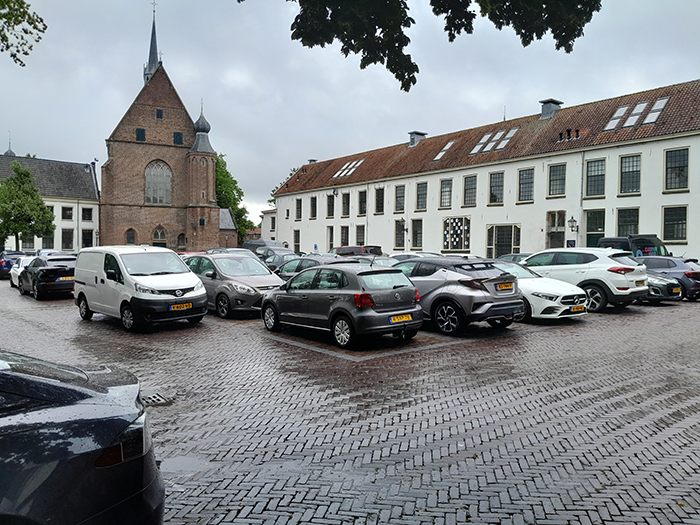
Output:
(0, 280), (700, 525)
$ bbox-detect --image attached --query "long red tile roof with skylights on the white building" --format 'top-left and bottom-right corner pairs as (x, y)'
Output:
(275, 80), (700, 196)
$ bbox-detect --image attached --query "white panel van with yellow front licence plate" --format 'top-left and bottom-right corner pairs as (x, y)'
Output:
(73, 246), (207, 331)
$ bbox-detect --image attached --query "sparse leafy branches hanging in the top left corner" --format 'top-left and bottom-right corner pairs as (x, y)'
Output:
(0, 0), (47, 67)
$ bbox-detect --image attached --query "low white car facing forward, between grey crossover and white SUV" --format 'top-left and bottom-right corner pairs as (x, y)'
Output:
(493, 261), (587, 321)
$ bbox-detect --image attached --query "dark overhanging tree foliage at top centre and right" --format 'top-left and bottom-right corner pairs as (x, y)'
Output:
(238, 0), (601, 91)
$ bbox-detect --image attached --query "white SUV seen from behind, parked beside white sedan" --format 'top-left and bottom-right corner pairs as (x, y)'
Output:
(520, 248), (648, 312)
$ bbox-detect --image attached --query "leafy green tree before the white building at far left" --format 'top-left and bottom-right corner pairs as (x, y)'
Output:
(0, 162), (56, 250)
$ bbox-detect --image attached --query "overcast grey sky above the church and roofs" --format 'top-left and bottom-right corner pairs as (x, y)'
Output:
(0, 0), (700, 224)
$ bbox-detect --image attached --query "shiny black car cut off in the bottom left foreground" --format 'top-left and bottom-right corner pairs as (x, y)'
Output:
(0, 350), (165, 525)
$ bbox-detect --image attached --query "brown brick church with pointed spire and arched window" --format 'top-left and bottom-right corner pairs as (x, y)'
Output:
(100, 12), (237, 251)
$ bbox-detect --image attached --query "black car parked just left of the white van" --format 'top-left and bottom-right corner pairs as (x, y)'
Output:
(17, 255), (76, 300)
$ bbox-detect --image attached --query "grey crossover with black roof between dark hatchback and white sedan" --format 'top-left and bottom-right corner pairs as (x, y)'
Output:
(394, 257), (525, 335)
